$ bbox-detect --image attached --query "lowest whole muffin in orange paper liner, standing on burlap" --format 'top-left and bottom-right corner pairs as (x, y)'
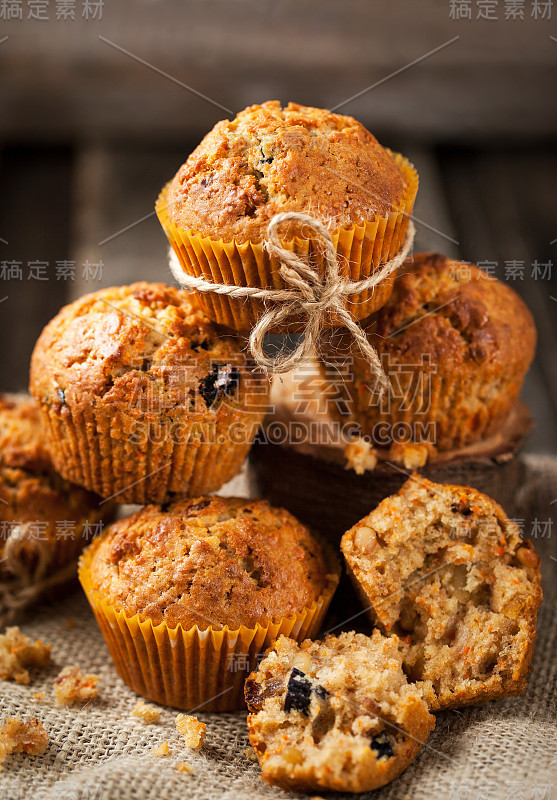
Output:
(80, 497), (338, 710)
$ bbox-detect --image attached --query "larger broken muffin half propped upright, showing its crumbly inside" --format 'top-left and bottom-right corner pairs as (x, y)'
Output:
(341, 474), (542, 710)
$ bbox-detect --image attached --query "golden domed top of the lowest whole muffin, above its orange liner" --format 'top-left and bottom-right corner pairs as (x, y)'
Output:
(84, 497), (327, 629)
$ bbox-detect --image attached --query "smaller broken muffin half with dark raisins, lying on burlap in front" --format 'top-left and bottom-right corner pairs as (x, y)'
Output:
(245, 631), (435, 792)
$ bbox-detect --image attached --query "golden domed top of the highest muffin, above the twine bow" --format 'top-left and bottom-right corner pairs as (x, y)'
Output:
(161, 100), (407, 241)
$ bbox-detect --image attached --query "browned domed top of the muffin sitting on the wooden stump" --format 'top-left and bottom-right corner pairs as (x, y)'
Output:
(366, 253), (536, 373)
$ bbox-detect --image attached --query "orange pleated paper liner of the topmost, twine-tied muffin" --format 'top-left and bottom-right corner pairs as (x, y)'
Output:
(155, 153), (418, 333)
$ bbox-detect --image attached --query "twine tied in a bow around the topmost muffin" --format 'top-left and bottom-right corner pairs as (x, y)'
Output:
(170, 211), (415, 395)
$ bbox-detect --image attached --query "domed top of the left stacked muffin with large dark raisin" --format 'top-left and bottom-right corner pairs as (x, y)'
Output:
(30, 282), (262, 419)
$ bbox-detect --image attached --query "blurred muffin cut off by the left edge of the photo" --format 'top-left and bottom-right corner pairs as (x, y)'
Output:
(0, 395), (111, 625)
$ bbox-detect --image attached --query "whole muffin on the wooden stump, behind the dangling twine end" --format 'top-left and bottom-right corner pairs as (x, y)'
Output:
(323, 253), (536, 456)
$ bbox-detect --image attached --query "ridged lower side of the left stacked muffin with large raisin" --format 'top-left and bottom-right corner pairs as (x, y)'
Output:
(41, 406), (260, 503)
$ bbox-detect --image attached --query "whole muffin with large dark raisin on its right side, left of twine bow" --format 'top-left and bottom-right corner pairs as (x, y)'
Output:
(30, 283), (268, 503)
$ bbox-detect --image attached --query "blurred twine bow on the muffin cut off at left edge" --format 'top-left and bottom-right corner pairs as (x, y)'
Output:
(0, 523), (76, 626)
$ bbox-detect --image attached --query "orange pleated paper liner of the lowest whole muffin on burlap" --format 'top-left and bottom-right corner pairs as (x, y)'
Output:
(79, 543), (340, 711)
